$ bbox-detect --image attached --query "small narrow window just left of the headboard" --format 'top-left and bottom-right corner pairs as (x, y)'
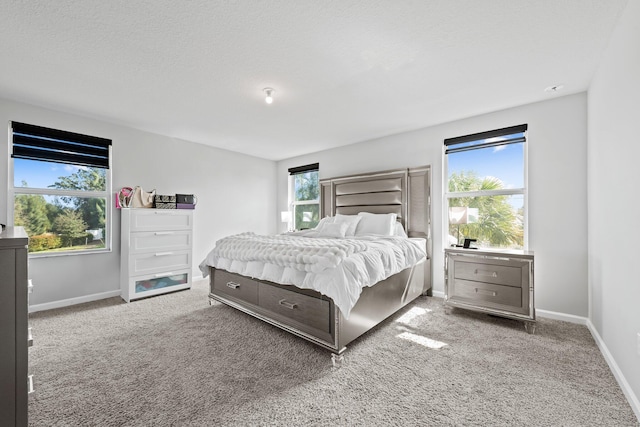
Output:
(289, 163), (320, 230)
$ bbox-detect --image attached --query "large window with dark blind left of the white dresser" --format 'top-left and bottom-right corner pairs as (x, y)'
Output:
(8, 122), (111, 255)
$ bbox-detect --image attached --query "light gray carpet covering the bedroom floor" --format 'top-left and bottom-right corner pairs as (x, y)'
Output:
(29, 281), (640, 426)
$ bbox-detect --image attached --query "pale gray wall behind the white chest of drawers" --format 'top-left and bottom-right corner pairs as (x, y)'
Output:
(0, 99), (276, 304)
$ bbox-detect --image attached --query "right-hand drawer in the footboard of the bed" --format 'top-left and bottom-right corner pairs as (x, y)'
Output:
(259, 283), (331, 333)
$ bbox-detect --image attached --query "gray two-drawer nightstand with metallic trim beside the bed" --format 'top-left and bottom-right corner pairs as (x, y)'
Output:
(444, 248), (536, 334)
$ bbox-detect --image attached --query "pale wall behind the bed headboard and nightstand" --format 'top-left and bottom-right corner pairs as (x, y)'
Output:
(277, 93), (587, 317)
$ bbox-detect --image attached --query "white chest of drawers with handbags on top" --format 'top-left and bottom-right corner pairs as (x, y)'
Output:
(120, 208), (193, 302)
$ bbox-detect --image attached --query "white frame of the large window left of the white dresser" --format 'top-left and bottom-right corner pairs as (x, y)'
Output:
(7, 122), (113, 258)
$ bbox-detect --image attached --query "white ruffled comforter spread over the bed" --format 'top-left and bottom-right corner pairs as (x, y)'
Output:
(200, 233), (426, 318)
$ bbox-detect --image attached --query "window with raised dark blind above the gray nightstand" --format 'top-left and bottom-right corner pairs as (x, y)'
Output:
(444, 124), (527, 249)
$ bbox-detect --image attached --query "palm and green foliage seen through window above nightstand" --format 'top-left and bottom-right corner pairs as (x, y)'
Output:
(449, 172), (524, 247)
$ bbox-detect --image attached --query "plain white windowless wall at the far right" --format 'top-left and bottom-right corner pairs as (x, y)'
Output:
(588, 1), (640, 417)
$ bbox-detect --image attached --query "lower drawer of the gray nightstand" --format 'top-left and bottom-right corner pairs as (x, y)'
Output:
(449, 279), (522, 310)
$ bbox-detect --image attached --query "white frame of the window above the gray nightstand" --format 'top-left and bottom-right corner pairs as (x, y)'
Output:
(442, 124), (529, 251)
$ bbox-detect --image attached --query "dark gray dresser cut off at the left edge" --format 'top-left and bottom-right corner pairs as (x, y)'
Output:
(0, 227), (33, 426)
